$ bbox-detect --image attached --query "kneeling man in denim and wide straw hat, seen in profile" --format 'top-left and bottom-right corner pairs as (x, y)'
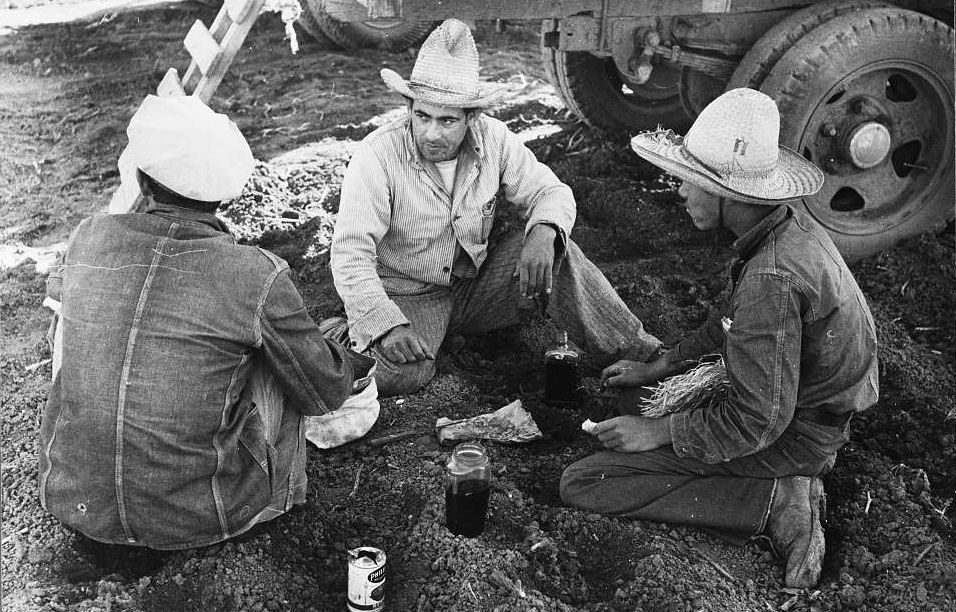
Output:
(561, 89), (878, 588)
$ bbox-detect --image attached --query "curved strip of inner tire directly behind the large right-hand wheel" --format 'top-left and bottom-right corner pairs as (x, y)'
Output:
(727, 0), (892, 90)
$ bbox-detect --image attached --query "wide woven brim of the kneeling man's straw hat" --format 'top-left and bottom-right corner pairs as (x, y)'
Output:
(631, 130), (823, 204)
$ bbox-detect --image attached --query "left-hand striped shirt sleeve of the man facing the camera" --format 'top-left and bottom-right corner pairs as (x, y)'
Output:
(331, 146), (408, 352)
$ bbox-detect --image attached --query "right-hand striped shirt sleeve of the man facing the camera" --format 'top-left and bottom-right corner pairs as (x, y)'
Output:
(501, 130), (577, 253)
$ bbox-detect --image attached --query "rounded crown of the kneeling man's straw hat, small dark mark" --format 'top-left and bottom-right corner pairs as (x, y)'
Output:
(684, 88), (780, 177)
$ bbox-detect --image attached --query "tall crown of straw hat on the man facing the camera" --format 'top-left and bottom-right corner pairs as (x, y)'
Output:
(409, 19), (480, 98)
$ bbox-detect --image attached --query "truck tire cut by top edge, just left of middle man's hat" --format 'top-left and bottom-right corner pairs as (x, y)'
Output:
(305, 0), (437, 51)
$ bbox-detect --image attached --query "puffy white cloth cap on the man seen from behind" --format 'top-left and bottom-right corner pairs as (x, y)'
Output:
(124, 95), (254, 202)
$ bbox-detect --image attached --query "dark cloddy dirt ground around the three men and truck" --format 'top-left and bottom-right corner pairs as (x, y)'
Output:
(0, 4), (956, 612)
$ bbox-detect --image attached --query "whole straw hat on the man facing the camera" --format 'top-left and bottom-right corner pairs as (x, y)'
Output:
(382, 19), (502, 108)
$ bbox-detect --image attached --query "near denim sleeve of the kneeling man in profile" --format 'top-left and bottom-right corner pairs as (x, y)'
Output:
(670, 273), (804, 463)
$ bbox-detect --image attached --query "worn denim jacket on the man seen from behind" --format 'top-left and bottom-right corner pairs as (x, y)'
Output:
(39, 202), (353, 549)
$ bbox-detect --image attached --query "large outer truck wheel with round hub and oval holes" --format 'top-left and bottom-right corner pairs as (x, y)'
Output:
(760, 8), (956, 261)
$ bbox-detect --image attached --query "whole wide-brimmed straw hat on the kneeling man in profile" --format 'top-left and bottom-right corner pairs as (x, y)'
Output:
(631, 88), (823, 204)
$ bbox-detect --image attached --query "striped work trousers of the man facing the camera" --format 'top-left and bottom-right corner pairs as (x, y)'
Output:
(366, 233), (660, 397)
